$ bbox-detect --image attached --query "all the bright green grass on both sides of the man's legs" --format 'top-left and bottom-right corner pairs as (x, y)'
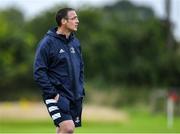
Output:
(0, 111), (180, 133)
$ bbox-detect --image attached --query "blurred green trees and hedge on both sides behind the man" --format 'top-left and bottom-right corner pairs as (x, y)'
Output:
(0, 1), (180, 100)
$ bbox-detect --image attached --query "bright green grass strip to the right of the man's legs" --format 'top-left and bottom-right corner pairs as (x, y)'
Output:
(79, 113), (180, 133)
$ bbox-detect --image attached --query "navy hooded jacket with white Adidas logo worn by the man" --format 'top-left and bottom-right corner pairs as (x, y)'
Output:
(34, 28), (85, 101)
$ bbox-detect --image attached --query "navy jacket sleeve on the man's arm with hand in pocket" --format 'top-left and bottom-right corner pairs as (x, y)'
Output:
(33, 42), (57, 99)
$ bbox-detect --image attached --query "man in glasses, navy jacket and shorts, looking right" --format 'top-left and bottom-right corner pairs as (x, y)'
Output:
(34, 8), (85, 134)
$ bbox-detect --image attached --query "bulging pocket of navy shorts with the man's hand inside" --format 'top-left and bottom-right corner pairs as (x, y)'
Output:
(57, 95), (70, 112)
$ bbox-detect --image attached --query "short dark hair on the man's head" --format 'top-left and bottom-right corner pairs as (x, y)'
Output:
(56, 8), (75, 26)
